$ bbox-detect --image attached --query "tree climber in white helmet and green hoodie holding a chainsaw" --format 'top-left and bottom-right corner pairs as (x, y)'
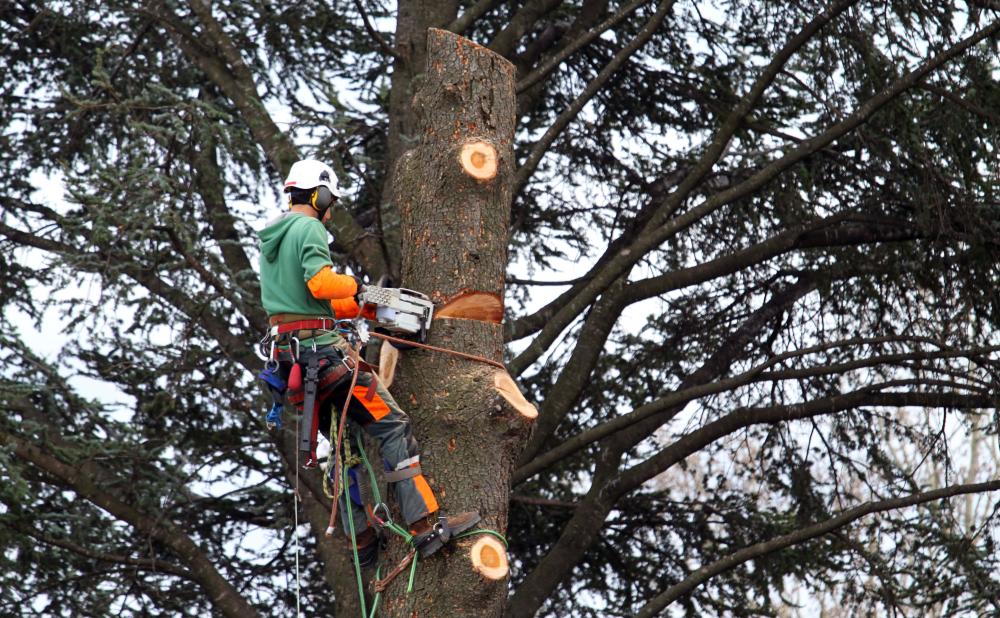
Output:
(258, 159), (479, 566)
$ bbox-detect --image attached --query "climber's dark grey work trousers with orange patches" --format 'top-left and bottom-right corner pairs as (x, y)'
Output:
(282, 345), (438, 534)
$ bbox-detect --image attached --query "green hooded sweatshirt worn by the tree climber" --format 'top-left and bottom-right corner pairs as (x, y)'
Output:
(257, 212), (333, 317)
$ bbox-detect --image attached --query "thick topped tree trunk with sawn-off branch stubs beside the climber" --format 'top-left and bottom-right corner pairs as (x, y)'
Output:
(384, 29), (528, 616)
